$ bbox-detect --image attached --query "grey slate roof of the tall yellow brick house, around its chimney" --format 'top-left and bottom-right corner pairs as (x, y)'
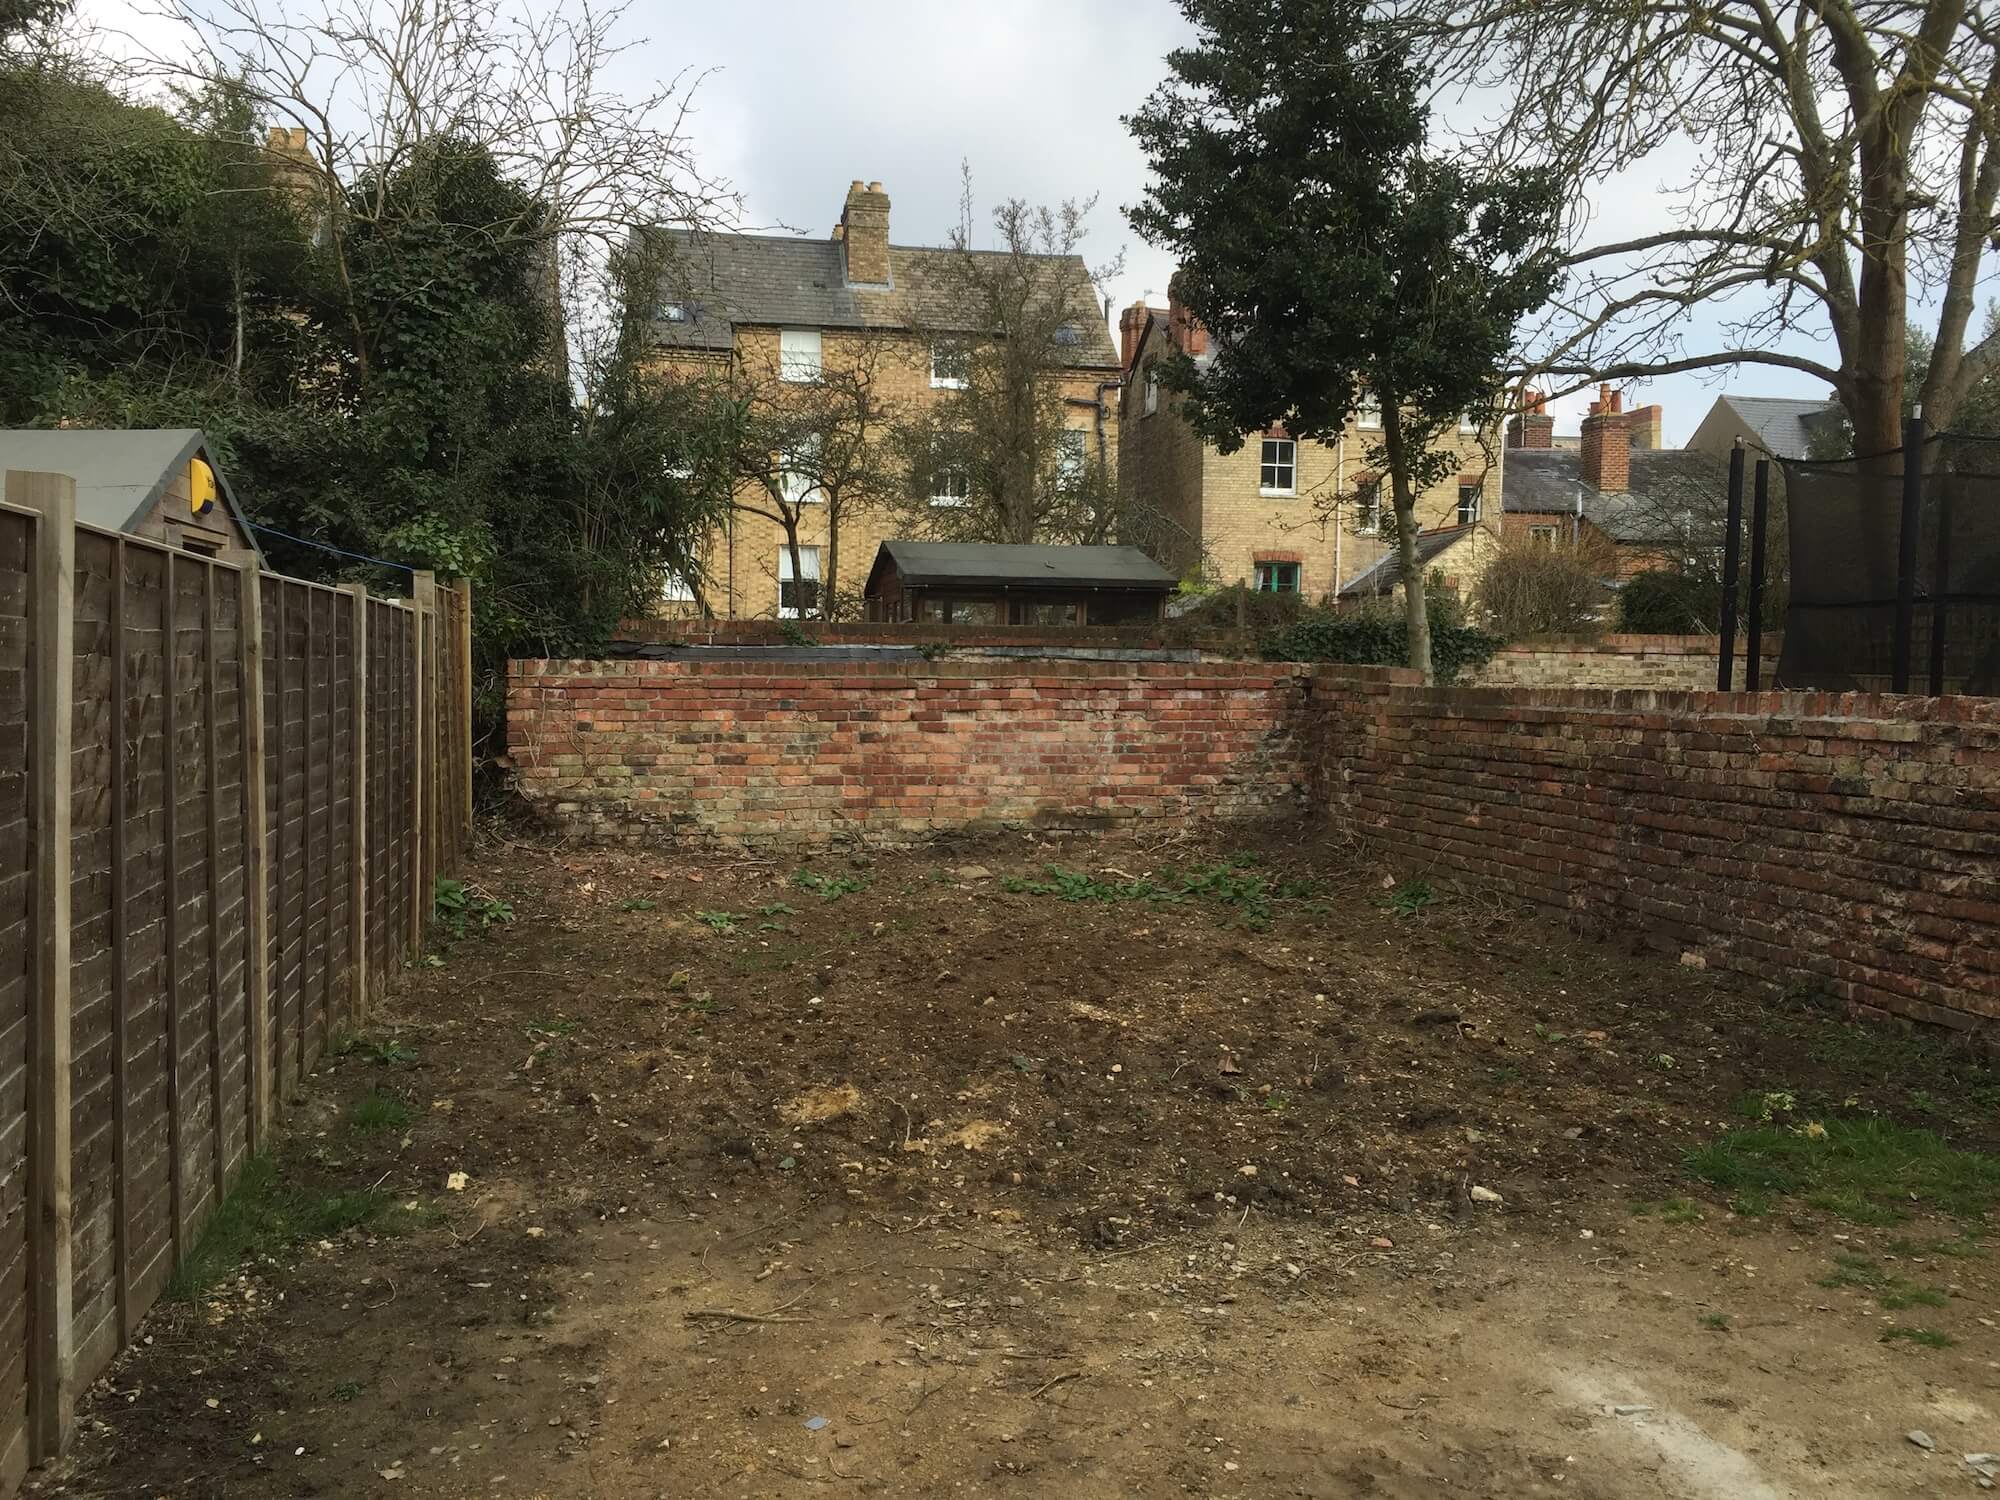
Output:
(652, 230), (1118, 370)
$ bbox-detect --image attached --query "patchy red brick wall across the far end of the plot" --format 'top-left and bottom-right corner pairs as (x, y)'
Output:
(508, 662), (1306, 844)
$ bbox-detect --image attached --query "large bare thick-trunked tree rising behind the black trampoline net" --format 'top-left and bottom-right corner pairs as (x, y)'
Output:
(1408, 0), (2000, 454)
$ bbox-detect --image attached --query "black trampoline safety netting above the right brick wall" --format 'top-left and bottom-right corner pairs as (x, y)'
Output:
(1778, 434), (2000, 694)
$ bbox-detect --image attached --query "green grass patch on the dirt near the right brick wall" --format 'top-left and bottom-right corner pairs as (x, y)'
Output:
(1686, 1120), (2000, 1224)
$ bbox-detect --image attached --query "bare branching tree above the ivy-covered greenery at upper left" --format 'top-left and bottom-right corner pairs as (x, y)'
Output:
(142, 0), (738, 386)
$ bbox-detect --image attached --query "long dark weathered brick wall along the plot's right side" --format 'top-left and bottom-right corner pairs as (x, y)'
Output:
(1308, 668), (2000, 1028)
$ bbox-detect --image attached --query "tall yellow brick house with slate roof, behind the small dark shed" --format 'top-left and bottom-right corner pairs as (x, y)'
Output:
(652, 182), (1120, 618)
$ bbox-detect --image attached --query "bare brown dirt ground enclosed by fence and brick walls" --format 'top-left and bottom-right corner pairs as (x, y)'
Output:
(38, 838), (2000, 1500)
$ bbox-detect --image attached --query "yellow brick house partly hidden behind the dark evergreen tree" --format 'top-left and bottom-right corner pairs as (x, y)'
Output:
(1118, 296), (1500, 602)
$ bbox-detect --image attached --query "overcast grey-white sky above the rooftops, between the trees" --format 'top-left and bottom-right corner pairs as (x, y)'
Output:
(84, 0), (1826, 442)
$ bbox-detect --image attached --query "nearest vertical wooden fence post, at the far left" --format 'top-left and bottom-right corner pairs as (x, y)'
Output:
(4, 472), (76, 1458)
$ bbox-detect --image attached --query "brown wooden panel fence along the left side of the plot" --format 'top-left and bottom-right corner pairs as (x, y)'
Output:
(0, 472), (472, 1496)
